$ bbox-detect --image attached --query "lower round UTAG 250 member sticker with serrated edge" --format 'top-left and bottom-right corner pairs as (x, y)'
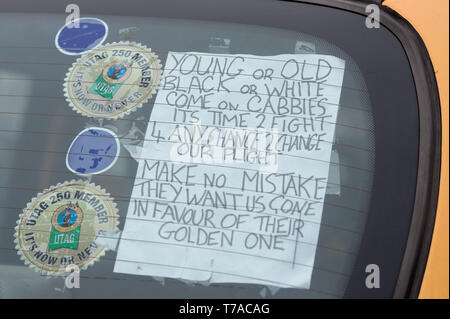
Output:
(14, 181), (119, 276)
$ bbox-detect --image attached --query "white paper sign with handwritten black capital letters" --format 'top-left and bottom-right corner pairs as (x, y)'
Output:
(114, 52), (345, 288)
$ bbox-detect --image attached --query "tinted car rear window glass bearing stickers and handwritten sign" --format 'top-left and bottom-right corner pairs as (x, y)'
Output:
(0, 1), (419, 298)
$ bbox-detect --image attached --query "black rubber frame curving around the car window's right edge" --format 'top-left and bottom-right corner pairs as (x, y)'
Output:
(2, 0), (442, 298)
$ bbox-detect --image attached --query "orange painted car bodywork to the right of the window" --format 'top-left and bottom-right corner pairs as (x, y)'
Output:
(383, 0), (449, 299)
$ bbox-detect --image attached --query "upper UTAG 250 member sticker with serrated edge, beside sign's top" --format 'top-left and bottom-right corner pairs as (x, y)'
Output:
(64, 42), (161, 119)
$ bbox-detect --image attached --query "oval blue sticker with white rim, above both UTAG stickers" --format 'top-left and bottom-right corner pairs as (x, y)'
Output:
(55, 18), (108, 55)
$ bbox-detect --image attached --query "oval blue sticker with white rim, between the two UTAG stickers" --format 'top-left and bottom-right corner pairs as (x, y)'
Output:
(66, 127), (120, 175)
